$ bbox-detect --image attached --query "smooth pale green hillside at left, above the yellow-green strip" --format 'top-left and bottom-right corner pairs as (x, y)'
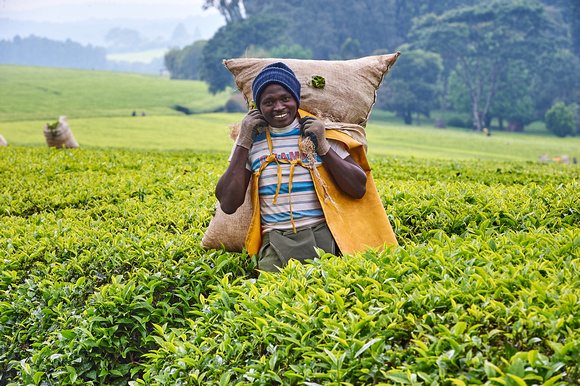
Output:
(0, 65), (231, 122)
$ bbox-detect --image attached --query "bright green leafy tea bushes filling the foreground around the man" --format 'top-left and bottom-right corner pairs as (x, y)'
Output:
(0, 148), (580, 386)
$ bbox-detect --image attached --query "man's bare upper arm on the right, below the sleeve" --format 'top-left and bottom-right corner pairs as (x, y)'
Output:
(320, 148), (367, 198)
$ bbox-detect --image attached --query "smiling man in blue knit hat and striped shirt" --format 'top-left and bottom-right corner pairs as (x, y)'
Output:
(215, 62), (390, 272)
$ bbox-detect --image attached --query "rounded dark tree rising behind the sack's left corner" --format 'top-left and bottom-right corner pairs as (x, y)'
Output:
(199, 14), (287, 93)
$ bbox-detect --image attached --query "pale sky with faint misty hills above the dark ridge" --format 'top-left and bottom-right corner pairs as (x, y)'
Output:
(0, 0), (225, 46)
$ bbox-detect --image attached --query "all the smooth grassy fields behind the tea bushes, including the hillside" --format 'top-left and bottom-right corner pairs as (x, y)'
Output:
(0, 65), (580, 161)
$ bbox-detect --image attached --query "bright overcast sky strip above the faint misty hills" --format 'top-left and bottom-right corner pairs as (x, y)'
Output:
(0, 0), (217, 21)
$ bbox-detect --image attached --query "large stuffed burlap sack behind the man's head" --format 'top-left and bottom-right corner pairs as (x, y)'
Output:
(223, 52), (400, 127)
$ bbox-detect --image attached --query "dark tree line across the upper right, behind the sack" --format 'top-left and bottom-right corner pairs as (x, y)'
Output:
(165, 0), (580, 136)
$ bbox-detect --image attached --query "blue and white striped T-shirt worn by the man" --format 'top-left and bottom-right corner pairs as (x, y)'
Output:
(234, 120), (349, 233)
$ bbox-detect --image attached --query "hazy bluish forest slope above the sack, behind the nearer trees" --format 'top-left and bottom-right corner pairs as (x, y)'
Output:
(243, 0), (490, 59)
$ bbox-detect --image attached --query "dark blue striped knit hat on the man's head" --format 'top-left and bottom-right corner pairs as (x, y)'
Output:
(252, 62), (300, 112)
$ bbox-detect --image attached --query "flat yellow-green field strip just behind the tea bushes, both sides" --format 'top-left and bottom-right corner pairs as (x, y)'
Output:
(0, 113), (580, 161)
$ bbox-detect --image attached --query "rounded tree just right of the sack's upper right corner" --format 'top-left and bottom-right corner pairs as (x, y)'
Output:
(377, 46), (443, 125)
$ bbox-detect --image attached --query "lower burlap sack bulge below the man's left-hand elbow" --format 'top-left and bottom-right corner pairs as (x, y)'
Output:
(201, 180), (253, 252)
